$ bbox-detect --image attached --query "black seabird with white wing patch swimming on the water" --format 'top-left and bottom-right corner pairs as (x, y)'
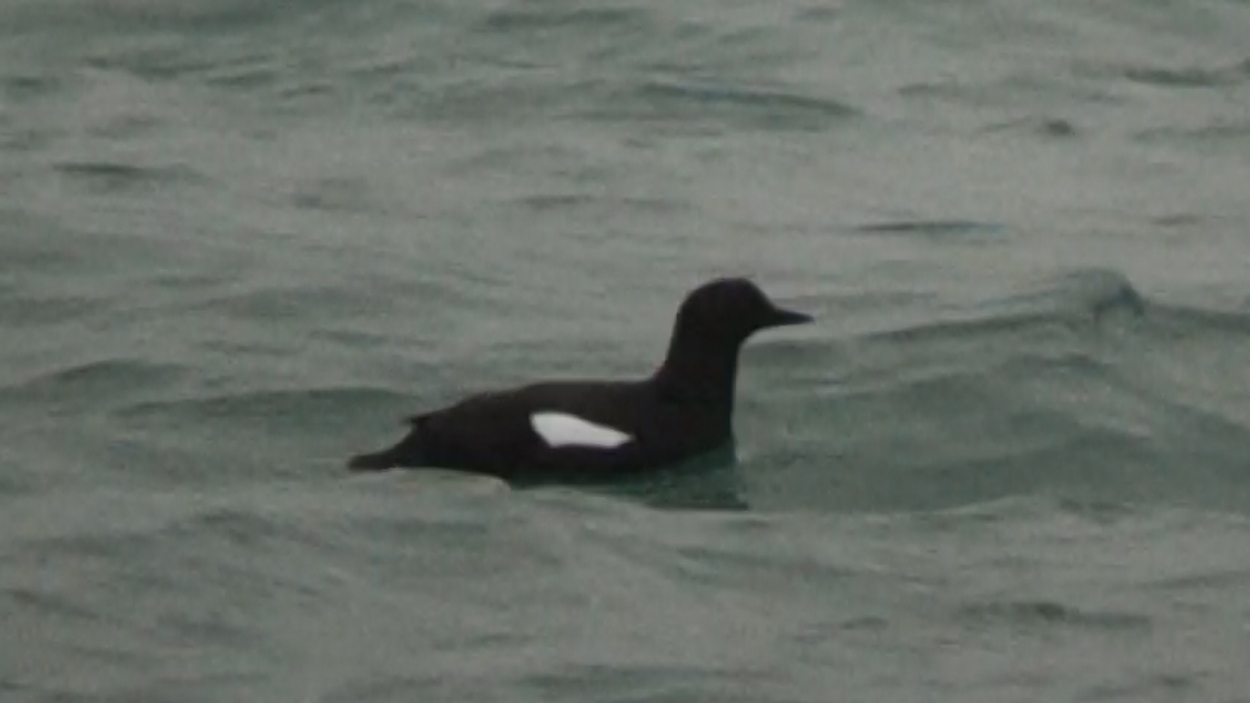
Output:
(348, 278), (813, 483)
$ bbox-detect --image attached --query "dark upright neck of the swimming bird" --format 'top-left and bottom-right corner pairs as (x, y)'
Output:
(654, 331), (740, 407)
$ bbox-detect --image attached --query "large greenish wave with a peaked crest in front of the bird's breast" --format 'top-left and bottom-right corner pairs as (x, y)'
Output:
(743, 270), (1250, 510)
